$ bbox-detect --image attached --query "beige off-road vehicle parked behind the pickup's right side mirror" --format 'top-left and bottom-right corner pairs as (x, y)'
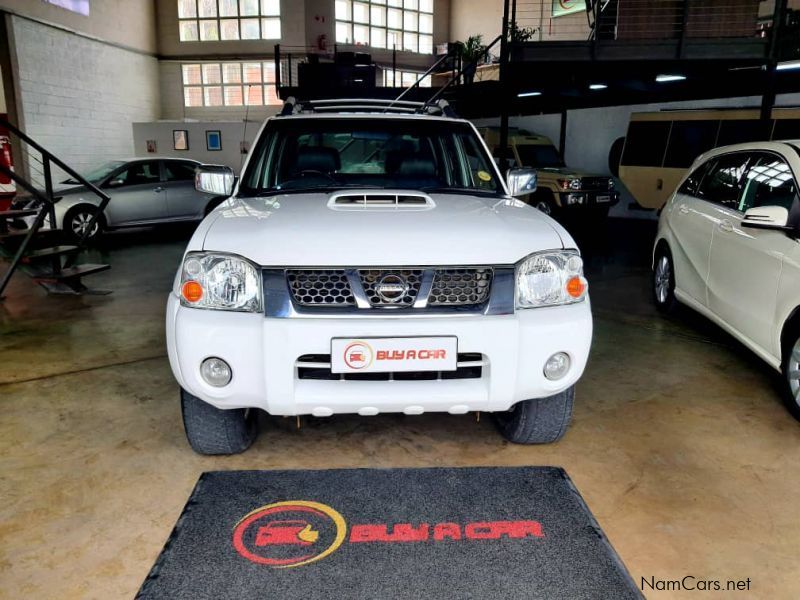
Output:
(479, 127), (619, 216)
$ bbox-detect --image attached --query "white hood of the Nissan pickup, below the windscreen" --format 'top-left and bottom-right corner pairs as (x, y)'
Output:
(202, 190), (568, 267)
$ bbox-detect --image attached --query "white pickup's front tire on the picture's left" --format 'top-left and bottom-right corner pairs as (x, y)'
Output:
(181, 389), (258, 454)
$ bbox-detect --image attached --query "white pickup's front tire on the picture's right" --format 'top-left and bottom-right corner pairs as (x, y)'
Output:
(495, 386), (575, 444)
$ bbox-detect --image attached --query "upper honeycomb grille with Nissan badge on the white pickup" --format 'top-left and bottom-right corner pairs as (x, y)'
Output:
(286, 267), (494, 309)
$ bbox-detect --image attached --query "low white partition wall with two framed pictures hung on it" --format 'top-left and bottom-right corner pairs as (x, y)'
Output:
(133, 119), (263, 173)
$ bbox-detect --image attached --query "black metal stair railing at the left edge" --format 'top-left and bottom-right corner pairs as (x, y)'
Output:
(0, 119), (111, 297)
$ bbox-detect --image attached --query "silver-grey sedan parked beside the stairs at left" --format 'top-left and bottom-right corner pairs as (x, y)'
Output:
(14, 158), (225, 244)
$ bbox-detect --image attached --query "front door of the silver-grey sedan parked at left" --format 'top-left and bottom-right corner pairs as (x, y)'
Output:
(103, 160), (167, 226)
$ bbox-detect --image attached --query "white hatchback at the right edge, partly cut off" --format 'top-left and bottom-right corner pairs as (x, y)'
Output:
(653, 142), (800, 418)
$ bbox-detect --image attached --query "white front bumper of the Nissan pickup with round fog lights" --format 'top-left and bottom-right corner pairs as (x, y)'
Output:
(167, 293), (592, 416)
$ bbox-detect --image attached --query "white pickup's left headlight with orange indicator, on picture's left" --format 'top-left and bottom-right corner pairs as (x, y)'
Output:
(180, 252), (261, 312)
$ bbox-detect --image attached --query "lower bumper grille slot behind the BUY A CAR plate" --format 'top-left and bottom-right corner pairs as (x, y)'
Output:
(296, 352), (486, 381)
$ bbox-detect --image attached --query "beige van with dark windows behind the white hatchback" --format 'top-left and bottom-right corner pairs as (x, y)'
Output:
(619, 108), (800, 209)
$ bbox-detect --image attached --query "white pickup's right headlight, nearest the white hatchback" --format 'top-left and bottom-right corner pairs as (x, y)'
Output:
(516, 250), (589, 308)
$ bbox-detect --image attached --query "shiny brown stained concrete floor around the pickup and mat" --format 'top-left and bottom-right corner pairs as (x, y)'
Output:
(0, 221), (800, 599)
